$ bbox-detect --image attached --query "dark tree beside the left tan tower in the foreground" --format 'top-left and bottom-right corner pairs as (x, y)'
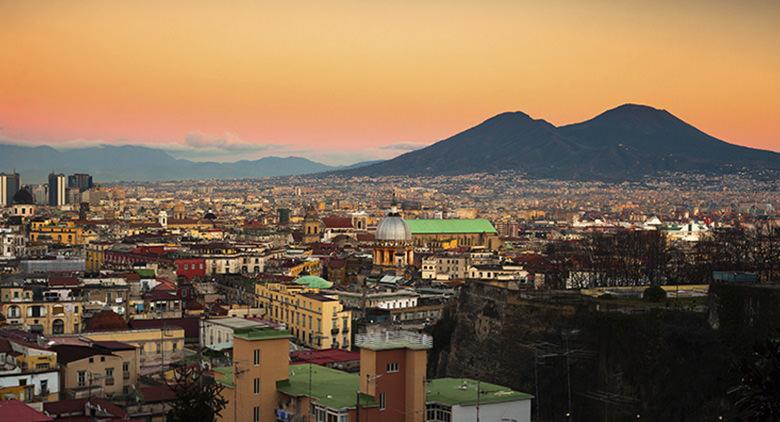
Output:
(168, 363), (227, 422)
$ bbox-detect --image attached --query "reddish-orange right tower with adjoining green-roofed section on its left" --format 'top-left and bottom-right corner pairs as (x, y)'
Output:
(277, 331), (433, 422)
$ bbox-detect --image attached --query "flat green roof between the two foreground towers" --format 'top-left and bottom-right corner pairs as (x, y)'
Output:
(276, 364), (377, 409)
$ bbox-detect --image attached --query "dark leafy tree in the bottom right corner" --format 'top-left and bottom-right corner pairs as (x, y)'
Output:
(729, 338), (780, 422)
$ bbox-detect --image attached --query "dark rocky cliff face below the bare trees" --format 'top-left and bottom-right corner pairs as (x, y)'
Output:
(431, 283), (732, 420)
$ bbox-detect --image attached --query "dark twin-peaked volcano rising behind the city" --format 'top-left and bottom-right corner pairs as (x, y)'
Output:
(342, 104), (780, 180)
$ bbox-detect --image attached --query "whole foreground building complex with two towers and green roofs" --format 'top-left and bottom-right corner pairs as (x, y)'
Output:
(213, 328), (532, 422)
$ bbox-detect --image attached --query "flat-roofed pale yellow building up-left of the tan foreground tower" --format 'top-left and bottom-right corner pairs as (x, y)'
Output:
(83, 327), (184, 375)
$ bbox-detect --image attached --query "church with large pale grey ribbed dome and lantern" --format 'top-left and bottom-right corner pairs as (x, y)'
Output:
(373, 197), (414, 268)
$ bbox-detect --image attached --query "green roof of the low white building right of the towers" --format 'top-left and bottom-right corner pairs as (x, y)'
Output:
(426, 378), (533, 406)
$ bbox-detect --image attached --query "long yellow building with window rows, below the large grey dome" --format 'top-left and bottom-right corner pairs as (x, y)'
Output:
(255, 276), (352, 350)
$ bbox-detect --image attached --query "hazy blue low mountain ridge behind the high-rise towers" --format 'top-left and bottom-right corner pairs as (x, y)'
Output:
(0, 144), (338, 183)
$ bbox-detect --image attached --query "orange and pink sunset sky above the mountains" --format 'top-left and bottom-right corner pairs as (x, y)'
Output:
(0, 0), (780, 164)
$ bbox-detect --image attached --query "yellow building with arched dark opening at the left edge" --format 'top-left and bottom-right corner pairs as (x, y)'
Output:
(0, 287), (83, 336)
